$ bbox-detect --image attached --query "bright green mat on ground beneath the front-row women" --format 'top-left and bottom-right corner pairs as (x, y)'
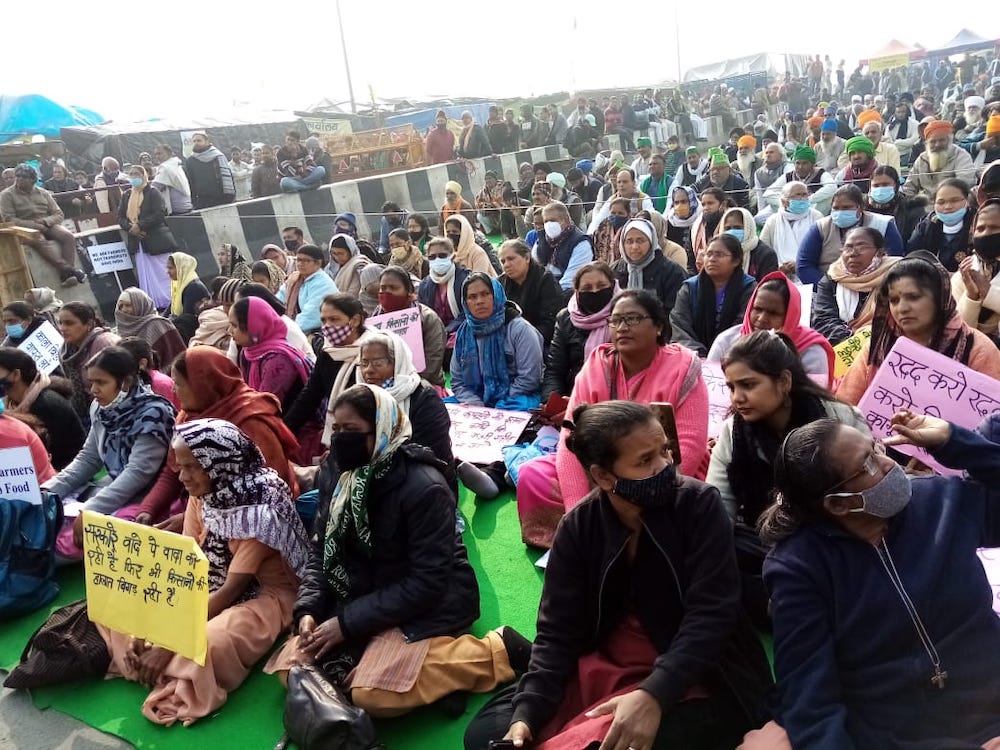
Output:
(0, 489), (542, 750)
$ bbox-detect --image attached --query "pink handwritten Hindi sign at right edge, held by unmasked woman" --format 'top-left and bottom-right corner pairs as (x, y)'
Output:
(858, 336), (1000, 476)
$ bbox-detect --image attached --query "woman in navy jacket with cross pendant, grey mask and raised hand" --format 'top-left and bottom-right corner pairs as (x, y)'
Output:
(744, 411), (1000, 750)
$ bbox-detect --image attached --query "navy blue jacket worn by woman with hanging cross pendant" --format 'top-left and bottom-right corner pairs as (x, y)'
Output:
(764, 425), (1000, 750)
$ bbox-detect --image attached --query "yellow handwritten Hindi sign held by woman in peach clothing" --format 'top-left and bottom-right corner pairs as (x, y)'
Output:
(83, 510), (208, 665)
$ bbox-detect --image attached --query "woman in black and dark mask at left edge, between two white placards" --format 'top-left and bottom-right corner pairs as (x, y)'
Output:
(0, 346), (80, 471)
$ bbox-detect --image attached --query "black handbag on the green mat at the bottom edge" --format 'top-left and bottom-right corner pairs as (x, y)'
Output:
(279, 665), (384, 750)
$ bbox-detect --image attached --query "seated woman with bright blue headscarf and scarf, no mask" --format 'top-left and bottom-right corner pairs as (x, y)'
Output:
(451, 272), (542, 411)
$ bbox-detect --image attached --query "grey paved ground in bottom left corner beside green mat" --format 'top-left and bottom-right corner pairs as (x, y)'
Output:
(0, 688), (132, 750)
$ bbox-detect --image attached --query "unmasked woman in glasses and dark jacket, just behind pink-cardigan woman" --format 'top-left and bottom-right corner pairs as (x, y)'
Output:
(670, 234), (757, 357)
